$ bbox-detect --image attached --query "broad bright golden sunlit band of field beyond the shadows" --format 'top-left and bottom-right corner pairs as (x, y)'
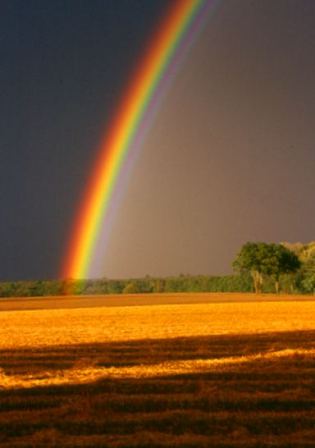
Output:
(0, 294), (315, 349)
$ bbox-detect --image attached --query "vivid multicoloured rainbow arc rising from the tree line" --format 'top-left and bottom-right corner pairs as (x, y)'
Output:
(61, 0), (211, 279)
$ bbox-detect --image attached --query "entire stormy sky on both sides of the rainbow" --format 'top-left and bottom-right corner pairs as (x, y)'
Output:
(0, 0), (315, 280)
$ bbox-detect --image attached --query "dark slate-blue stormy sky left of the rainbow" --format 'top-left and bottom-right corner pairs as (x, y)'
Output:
(0, 0), (167, 279)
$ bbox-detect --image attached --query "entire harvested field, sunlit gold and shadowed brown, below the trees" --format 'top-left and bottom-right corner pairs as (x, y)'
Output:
(0, 294), (315, 447)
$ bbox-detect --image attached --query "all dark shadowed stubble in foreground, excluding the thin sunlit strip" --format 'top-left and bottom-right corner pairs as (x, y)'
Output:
(0, 331), (315, 448)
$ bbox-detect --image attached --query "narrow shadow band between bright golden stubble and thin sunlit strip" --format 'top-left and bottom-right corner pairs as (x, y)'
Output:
(0, 331), (315, 375)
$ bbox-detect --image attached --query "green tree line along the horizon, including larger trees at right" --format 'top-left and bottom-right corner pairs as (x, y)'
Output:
(0, 241), (315, 297)
